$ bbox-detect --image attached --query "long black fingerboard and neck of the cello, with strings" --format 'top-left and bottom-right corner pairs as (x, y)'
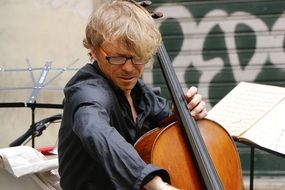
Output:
(157, 43), (224, 190)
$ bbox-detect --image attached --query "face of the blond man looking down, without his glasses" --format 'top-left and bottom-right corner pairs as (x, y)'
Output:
(92, 41), (144, 94)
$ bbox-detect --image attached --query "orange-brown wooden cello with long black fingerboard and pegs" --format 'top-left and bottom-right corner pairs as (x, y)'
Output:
(135, 1), (244, 190)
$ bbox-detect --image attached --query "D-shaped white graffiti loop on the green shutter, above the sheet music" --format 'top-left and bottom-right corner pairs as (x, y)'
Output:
(220, 12), (270, 81)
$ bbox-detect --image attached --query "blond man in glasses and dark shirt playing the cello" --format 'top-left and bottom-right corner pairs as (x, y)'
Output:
(59, 1), (206, 190)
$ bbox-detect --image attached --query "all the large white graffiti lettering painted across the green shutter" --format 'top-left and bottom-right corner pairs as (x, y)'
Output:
(153, 5), (285, 101)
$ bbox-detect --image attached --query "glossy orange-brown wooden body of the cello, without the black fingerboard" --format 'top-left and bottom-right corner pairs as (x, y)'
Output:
(135, 117), (244, 190)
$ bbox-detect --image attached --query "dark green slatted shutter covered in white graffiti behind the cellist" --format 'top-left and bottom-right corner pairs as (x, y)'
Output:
(144, 0), (285, 175)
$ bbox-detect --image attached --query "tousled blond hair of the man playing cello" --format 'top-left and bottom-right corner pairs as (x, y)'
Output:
(83, 0), (161, 59)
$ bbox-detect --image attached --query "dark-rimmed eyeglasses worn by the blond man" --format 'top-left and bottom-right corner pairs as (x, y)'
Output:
(99, 47), (148, 65)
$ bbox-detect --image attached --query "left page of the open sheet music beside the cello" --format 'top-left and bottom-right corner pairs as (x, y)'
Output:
(207, 82), (285, 136)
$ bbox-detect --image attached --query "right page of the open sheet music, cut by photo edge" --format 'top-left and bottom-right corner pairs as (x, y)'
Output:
(242, 98), (285, 155)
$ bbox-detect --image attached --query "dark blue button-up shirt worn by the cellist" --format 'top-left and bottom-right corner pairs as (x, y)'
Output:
(58, 62), (171, 190)
